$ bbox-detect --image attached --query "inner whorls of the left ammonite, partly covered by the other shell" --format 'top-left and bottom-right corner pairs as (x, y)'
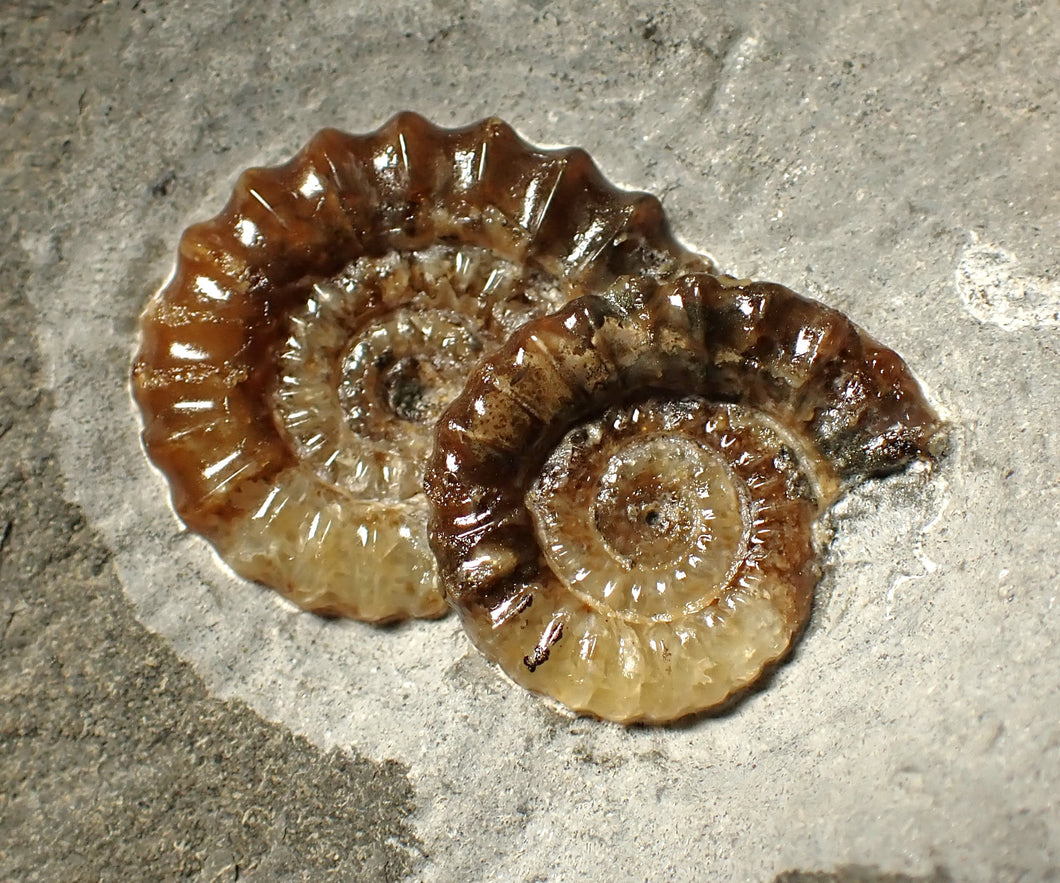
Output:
(273, 244), (563, 501)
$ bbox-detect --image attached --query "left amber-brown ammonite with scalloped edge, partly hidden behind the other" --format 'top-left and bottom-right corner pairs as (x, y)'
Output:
(133, 113), (710, 621)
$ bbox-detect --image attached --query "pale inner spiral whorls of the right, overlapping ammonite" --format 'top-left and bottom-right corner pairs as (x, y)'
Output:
(528, 402), (747, 620)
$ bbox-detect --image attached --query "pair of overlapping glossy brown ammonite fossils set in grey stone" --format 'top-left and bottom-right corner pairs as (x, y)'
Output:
(133, 113), (941, 722)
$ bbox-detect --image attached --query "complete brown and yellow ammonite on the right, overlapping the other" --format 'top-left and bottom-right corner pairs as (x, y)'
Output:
(426, 275), (942, 722)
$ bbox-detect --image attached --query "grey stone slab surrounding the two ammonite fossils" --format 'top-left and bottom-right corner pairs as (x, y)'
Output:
(0, 0), (1060, 883)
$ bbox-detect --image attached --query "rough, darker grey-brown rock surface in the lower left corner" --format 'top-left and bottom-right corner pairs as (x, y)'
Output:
(0, 155), (418, 881)
